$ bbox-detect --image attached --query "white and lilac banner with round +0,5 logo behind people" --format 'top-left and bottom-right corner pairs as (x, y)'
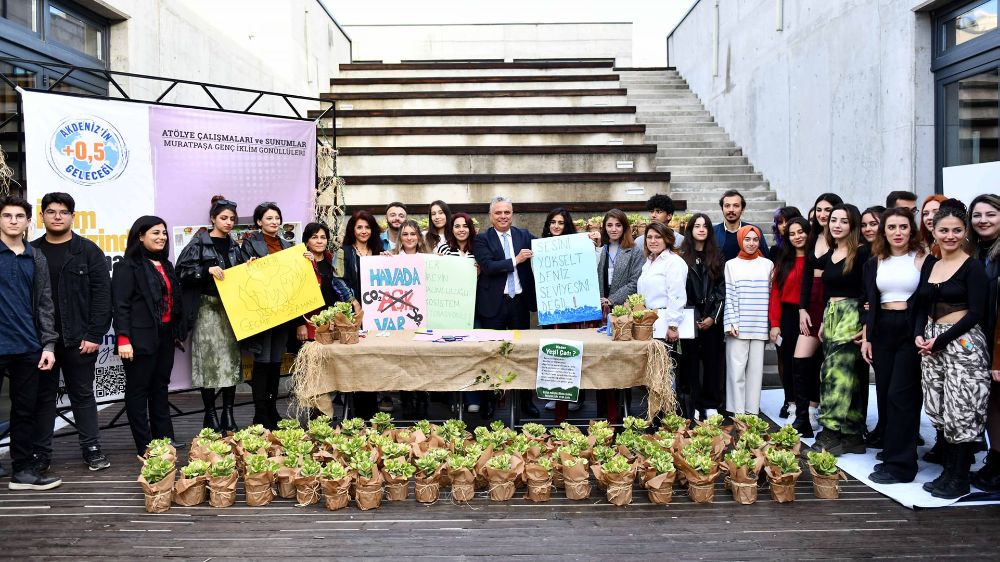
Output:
(19, 90), (316, 394)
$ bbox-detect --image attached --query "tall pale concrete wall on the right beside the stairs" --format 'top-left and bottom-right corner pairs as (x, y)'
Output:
(667, 0), (935, 209)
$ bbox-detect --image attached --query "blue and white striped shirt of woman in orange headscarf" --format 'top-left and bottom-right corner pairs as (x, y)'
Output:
(723, 258), (774, 340)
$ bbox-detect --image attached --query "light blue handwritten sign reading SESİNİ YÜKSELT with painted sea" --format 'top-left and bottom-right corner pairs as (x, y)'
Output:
(531, 230), (601, 325)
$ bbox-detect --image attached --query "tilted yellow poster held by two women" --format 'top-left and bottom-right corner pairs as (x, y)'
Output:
(215, 244), (323, 340)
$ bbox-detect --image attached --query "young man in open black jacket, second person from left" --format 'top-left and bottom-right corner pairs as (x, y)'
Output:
(31, 192), (111, 472)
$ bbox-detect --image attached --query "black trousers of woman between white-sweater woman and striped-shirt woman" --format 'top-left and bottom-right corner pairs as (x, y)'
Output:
(679, 324), (726, 410)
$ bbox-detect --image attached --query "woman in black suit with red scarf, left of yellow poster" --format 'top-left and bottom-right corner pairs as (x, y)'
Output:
(111, 216), (187, 455)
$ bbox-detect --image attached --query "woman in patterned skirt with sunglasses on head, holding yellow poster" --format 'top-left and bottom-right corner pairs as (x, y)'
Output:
(177, 195), (244, 431)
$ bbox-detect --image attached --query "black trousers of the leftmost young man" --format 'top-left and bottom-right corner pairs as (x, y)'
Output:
(0, 351), (42, 474)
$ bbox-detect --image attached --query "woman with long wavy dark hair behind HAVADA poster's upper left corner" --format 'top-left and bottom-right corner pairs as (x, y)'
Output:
(334, 211), (382, 419)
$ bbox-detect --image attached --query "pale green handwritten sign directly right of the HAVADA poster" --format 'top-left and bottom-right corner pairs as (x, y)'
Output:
(424, 255), (476, 330)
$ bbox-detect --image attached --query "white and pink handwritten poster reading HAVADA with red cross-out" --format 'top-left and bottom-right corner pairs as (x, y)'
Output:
(361, 254), (427, 331)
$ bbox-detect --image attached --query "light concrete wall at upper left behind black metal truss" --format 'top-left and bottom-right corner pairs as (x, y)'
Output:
(96, 0), (351, 114)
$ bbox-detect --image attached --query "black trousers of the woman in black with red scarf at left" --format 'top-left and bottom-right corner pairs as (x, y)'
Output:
(122, 325), (174, 455)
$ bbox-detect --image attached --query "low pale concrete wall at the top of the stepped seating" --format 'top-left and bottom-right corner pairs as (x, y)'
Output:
(344, 23), (632, 66)
